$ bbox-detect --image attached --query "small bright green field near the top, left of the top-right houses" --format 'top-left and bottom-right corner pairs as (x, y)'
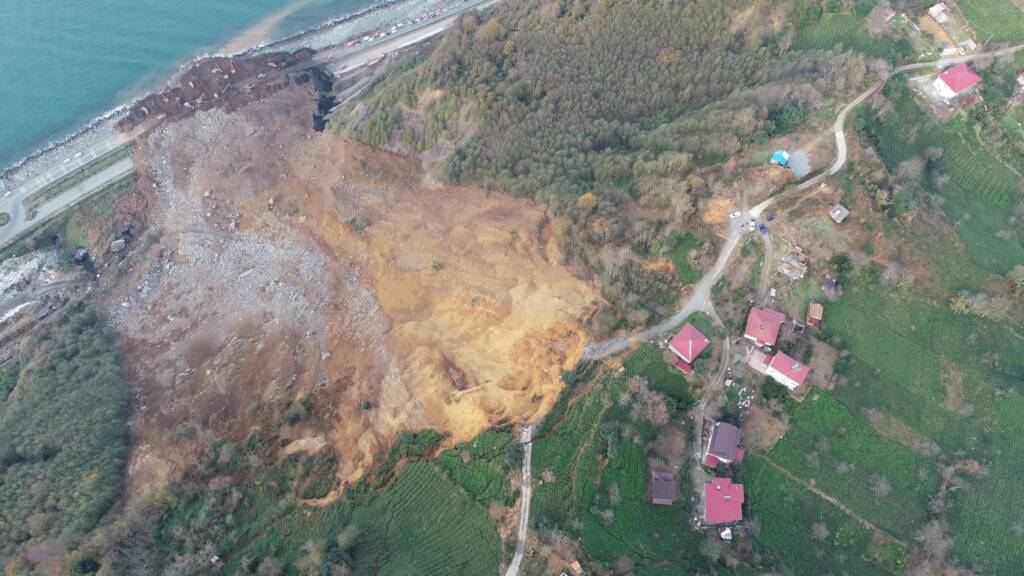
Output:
(793, 13), (906, 60)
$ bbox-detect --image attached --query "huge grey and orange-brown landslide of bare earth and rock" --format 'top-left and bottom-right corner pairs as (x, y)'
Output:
(118, 86), (598, 493)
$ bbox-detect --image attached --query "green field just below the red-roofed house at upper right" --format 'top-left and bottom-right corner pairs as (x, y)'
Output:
(861, 82), (1024, 275)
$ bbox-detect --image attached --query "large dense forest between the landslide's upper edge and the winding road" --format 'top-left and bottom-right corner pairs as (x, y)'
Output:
(335, 0), (864, 332)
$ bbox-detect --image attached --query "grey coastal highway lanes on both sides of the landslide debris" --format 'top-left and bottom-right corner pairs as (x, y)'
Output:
(0, 0), (501, 248)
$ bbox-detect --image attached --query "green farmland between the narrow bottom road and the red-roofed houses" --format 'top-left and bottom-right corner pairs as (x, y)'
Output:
(531, 347), (731, 576)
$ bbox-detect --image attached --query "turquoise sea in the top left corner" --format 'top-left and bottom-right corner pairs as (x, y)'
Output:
(0, 0), (379, 169)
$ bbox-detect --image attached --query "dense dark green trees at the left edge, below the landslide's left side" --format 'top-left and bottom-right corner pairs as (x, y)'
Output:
(0, 303), (129, 559)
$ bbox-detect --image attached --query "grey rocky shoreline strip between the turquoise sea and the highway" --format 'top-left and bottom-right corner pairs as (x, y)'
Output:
(0, 0), (442, 194)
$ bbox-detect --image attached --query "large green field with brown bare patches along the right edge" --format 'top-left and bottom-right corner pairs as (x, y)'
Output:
(823, 270), (1024, 574)
